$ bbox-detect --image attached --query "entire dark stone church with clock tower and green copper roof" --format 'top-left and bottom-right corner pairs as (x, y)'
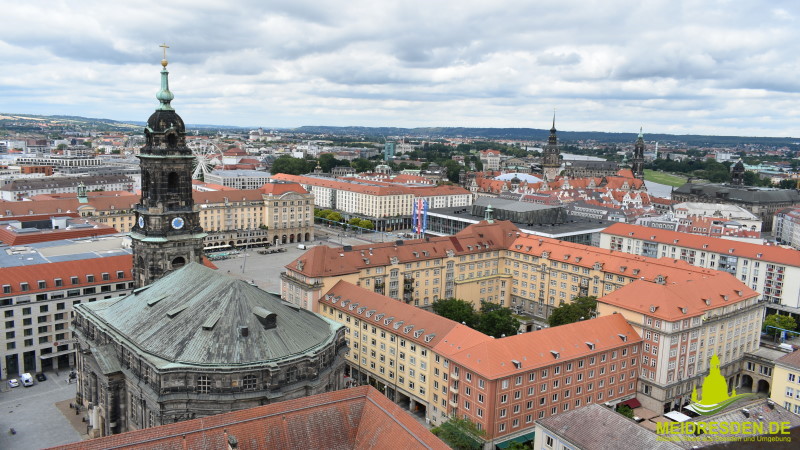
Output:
(72, 51), (348, 437)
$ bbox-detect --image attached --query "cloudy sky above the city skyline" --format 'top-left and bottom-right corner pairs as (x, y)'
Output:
(0, 0), (800, 136)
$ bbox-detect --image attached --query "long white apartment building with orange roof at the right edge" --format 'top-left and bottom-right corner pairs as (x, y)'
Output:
(600, 223), (800, 318)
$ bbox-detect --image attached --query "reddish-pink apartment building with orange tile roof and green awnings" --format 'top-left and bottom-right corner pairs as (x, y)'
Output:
(442, 315), (641, 441)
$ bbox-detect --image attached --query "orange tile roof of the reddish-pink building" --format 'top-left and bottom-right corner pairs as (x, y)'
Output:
(450, 314), (642, 379)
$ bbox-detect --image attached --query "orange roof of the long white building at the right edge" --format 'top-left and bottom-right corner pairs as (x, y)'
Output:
(603, 223), (800, 266)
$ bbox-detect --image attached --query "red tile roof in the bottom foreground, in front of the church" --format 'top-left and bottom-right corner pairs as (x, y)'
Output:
(54, 386), (449, 450)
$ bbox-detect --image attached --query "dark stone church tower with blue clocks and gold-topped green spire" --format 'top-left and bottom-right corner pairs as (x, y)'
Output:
(131, 45), (206, 288)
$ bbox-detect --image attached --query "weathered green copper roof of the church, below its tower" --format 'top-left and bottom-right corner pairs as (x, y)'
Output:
(77, 263), (341, 368)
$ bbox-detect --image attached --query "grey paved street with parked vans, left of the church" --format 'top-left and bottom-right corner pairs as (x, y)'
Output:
(0, 370), (85, 450)
